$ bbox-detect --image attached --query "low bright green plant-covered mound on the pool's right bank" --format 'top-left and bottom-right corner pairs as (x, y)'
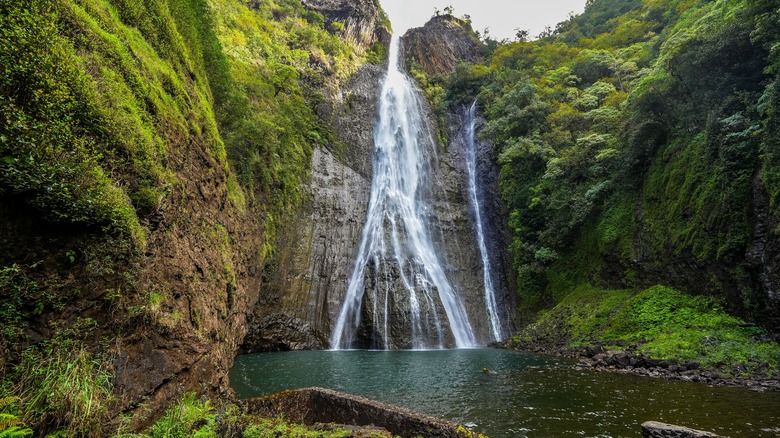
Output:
(513, 286), (780, 375)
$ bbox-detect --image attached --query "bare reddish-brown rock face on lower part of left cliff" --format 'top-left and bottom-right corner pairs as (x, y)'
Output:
(0, 131), (263, 432)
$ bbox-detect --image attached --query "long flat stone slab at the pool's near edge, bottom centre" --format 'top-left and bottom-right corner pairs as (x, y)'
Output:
(241, 387), (477, 438)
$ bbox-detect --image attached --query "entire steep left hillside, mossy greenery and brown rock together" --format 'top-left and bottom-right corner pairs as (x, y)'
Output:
(0, 0), (386, 435)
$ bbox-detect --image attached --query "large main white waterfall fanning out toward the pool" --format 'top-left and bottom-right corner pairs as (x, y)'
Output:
(330, 36), (477, 349)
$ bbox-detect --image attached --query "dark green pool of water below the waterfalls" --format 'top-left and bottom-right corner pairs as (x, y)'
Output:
(231, 349), (780, 438)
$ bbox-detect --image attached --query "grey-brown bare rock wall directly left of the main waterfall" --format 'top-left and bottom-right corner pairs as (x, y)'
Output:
(243, 65), (384, 352)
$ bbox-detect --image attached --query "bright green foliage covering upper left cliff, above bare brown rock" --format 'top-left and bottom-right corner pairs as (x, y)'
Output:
(0, 0), (364, 253)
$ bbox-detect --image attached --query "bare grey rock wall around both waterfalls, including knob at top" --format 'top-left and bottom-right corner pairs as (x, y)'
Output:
(243, 16), (514, 352)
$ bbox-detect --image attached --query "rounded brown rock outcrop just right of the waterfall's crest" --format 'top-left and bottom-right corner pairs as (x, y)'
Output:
(403, 15), (482, 75)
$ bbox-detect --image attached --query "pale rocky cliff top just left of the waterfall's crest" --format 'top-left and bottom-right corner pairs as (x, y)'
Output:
(301, 0), (390, 51)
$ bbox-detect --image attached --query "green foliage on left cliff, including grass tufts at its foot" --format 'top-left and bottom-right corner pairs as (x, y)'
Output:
(0, 0), (374, 436)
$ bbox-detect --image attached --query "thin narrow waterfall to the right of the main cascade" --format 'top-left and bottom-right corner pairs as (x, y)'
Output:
(464, 102), (504, 342)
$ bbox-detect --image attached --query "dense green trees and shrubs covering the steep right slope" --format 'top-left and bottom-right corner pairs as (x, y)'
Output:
(445, 0), (780, 320)
